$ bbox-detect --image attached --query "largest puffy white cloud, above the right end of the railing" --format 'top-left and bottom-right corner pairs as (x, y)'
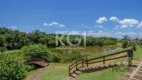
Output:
(119, 19), (139, 28)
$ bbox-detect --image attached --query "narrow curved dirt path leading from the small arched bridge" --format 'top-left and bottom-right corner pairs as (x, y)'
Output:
(25, 66), (50, 80)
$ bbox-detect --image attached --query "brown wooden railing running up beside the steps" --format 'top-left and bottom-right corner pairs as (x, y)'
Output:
(69, 49), (133, 76)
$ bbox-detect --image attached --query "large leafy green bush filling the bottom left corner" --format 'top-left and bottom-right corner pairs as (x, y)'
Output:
(0, 54), (27, 80)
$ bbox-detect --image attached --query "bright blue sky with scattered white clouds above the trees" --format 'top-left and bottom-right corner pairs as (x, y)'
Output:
(0, 0), (142, 37)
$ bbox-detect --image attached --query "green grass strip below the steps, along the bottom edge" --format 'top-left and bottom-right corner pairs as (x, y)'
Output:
(76, 68), (125, 80)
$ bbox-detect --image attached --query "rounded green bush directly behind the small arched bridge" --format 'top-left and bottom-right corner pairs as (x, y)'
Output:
(22, 44), (52, 61)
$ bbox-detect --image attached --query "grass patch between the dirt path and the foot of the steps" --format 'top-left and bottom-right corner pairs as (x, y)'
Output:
(40, 63), (69, 80)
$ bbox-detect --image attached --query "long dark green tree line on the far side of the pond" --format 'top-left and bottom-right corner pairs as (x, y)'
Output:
(0, 27), (117, 50)
